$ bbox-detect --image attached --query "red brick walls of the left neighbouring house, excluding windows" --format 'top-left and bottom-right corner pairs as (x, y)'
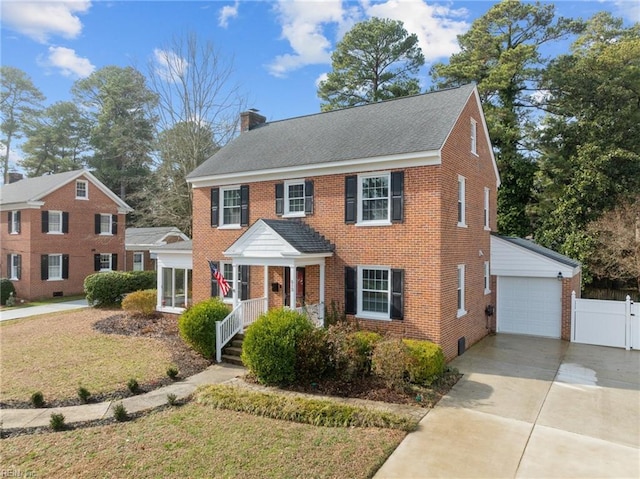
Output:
(0, 177), (125, 299)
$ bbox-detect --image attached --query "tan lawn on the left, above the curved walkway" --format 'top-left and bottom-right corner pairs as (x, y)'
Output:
(0, 309), (200, 407)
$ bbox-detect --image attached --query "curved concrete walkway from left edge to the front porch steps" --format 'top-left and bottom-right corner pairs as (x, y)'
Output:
(0, 364), (246, 431)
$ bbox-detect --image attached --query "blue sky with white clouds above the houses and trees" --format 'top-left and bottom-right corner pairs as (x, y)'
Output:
(1, 0), (640, 129)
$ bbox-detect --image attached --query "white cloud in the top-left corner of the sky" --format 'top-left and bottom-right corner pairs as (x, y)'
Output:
(1, 0), (91, 43)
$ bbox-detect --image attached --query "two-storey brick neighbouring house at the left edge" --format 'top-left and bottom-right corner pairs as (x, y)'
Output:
(0, 170), (132, 299)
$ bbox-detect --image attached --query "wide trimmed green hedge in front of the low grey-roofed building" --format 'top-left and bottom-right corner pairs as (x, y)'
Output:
(84, 271), (156, 306)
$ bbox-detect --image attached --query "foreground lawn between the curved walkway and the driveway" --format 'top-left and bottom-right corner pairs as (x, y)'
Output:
(2, 403), (405, 479)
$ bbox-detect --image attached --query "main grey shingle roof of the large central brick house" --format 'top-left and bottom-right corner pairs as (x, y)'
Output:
(187, 85), (475, 179)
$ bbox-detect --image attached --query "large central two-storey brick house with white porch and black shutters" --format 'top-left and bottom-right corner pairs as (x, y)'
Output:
(187, 85), (500, 358)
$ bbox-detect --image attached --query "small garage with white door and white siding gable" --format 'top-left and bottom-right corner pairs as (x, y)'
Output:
(491, 235), (581, 340)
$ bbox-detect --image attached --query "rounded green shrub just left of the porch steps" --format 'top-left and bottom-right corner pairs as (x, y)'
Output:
(178, 297), (230, 359)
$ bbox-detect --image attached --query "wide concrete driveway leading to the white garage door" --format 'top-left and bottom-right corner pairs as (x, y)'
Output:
(375, 335), (640, 478)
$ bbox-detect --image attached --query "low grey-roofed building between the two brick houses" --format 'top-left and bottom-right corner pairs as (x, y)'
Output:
(123, 226), (189, 271)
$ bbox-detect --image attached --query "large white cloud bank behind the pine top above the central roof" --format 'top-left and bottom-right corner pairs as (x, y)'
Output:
(268, 0), (469, 77)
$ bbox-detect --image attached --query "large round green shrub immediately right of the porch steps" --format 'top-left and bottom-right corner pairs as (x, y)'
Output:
(242, 308), (314, 384)
